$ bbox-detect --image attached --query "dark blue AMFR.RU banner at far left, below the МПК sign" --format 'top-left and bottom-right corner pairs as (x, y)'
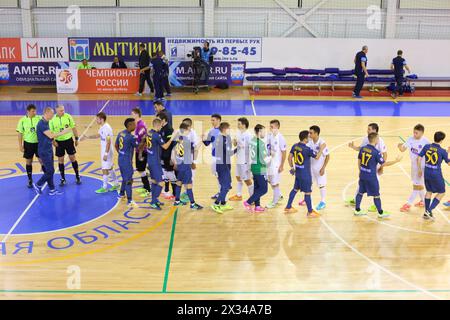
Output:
(0, 62), (69, 86)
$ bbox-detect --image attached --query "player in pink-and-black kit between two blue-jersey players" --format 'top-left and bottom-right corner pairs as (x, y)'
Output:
(131, 107), (151, 197)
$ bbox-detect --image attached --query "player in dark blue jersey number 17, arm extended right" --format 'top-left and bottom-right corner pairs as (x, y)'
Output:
(354, 132), (402, 219)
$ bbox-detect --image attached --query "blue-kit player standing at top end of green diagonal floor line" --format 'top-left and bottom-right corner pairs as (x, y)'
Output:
(172, 122), (203, 210)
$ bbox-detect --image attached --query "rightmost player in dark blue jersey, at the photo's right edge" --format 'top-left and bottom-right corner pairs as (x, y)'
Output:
(417, 131), (450, 220)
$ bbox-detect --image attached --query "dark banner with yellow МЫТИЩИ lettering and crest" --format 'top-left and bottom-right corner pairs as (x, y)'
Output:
(68, 37), (165, 63)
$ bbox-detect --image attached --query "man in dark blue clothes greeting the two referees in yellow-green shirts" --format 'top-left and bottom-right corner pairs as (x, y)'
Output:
(33, 107), (72, 196)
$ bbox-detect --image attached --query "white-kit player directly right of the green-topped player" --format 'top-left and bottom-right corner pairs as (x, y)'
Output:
(266, 120), (287, 209)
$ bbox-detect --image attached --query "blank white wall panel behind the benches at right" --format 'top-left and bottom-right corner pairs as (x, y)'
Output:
(247, 38), (450, 77)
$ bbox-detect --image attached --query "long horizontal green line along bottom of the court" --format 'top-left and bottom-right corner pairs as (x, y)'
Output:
(0, 289), (450, 295)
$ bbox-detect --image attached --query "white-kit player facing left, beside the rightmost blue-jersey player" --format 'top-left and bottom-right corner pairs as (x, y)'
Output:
(398, 124), (430, 212)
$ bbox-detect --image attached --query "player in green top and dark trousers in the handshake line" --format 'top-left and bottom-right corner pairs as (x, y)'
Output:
(243, 124), (271, 212)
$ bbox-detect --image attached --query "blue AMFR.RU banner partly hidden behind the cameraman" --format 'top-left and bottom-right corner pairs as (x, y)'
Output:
(169, 61), (245, 87)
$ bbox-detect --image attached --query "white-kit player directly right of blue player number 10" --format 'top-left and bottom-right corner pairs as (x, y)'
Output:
(307, 126), (330, 210)
